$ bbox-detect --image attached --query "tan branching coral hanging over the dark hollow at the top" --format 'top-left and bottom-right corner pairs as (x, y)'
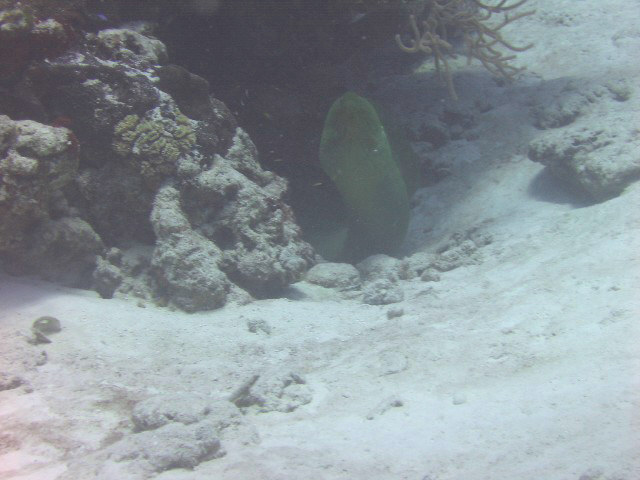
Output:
(396, 0), (535, 98)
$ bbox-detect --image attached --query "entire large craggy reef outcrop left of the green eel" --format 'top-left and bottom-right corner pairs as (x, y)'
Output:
(0, 15), (314, 311)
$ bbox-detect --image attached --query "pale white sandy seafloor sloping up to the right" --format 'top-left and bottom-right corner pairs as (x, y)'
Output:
(0, 0), (640, 480)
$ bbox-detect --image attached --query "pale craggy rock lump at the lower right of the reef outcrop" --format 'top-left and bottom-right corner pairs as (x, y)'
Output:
(151, 129), (313, 311)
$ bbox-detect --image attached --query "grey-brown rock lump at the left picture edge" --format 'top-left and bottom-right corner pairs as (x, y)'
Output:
(0, 116), (103, 285)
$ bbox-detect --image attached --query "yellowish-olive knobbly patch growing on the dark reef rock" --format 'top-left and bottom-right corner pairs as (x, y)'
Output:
(113, 109), (196, 184)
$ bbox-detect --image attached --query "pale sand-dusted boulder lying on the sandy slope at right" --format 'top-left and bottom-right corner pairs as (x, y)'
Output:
(529, 81), (640, 202)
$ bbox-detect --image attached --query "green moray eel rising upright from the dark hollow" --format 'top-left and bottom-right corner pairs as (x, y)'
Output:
(319, 92), (417, 261)
